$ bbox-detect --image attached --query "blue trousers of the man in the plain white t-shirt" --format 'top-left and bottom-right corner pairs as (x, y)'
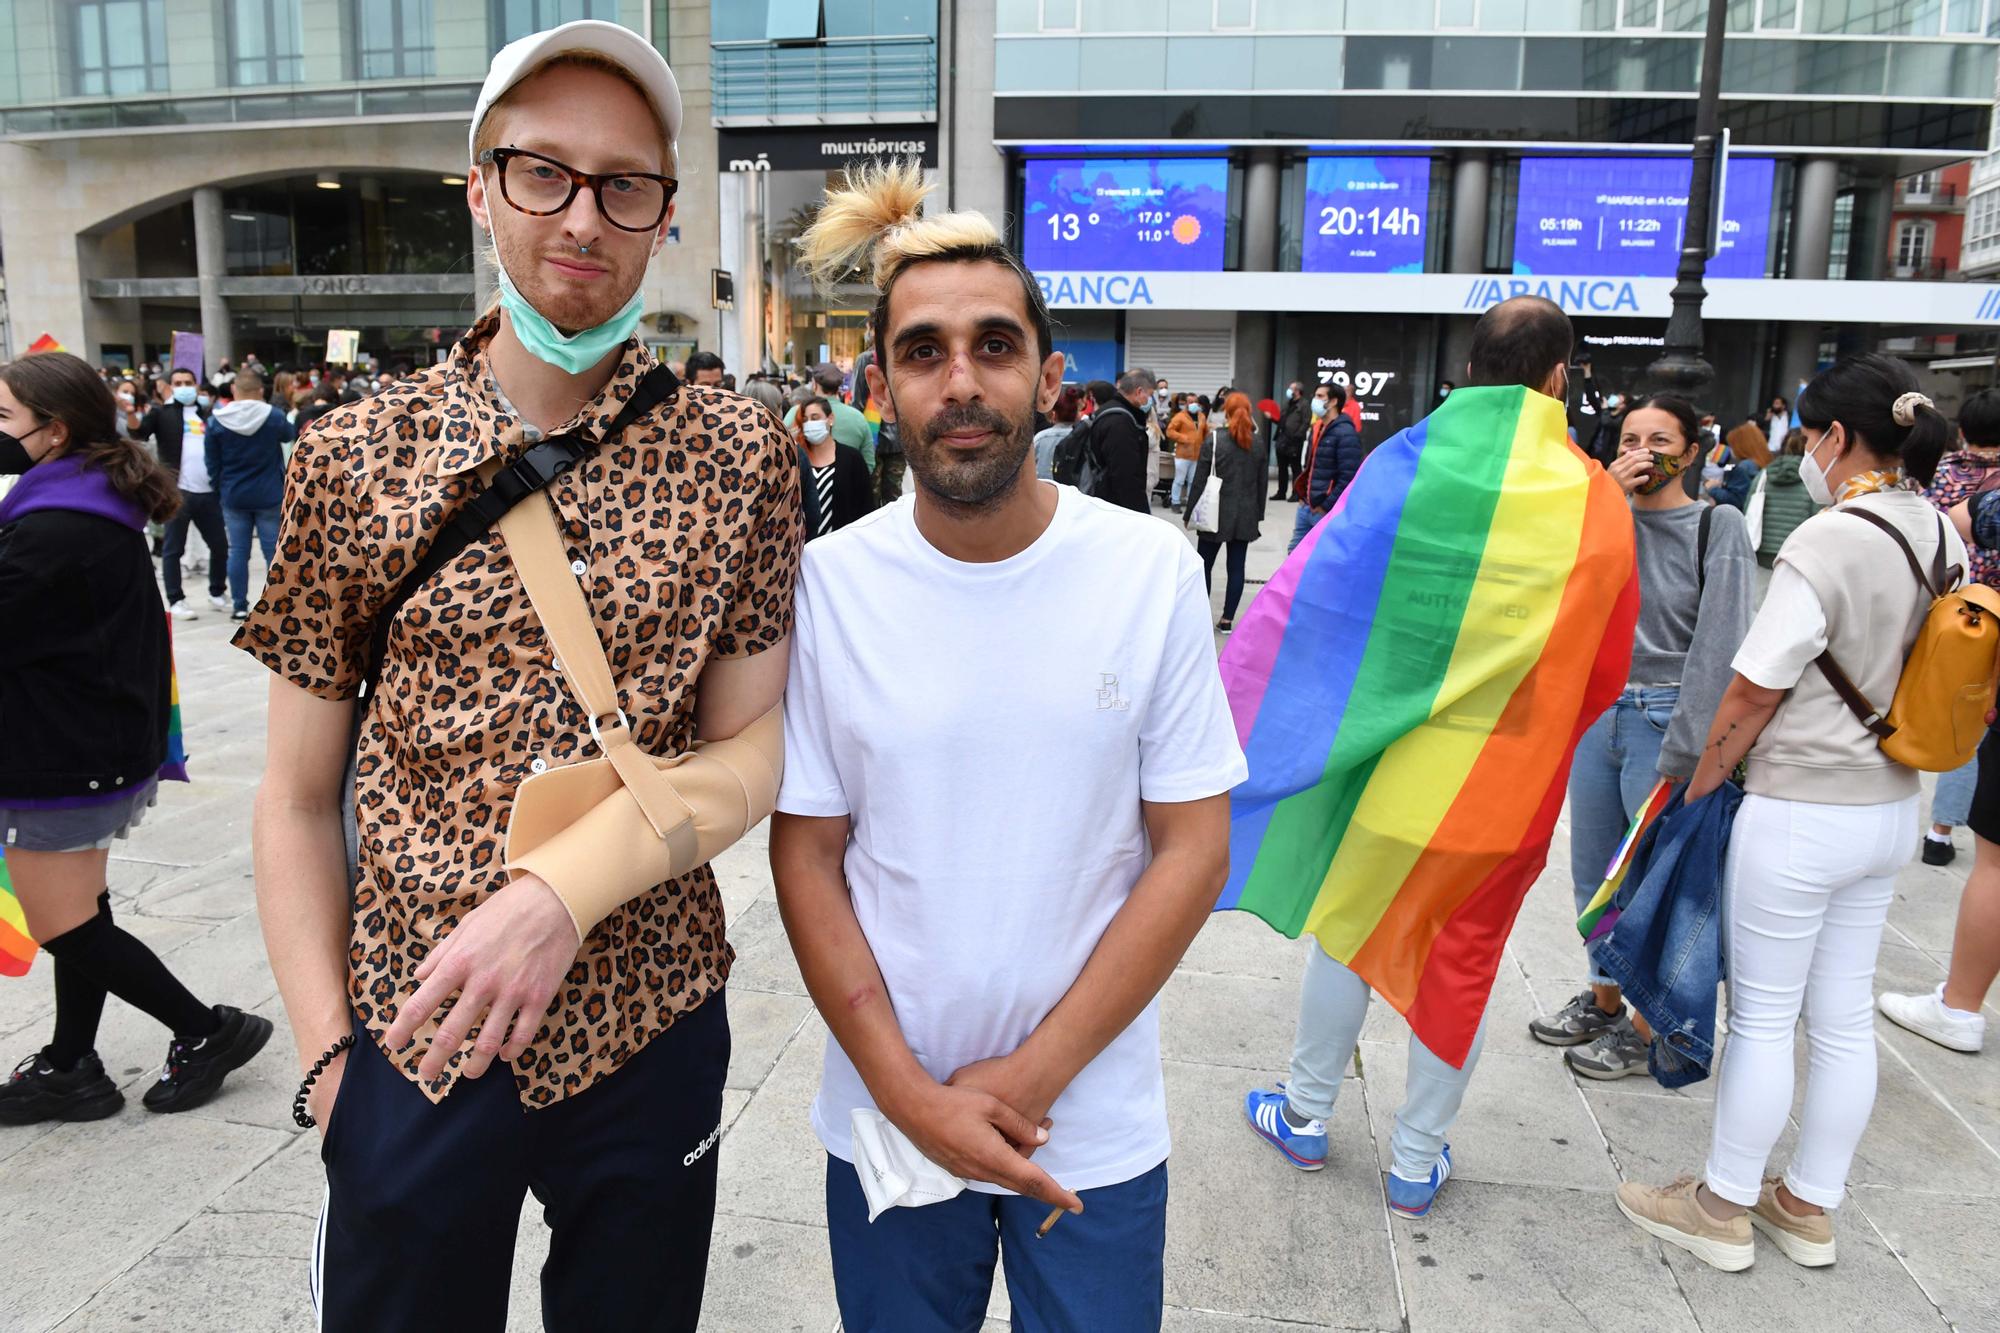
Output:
(826, 1155), (1166, 1333)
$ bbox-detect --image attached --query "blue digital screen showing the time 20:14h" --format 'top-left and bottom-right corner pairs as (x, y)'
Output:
(1300, 158), (1430, 272)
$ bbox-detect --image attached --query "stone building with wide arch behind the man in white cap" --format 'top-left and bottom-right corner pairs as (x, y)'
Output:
(0, 0), (716, 374)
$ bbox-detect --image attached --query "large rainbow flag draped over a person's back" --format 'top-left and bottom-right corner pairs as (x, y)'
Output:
(1216, 386), (1638, 1065)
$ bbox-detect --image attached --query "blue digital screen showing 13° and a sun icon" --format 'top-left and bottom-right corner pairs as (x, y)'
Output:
(1022, 158), (1230, 272)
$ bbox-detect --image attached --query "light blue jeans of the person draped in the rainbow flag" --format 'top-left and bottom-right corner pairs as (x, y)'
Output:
(1284, 943), (1486, 1181)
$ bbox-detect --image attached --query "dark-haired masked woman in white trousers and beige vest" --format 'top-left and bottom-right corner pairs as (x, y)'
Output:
(1618, 354), (1966, 1271)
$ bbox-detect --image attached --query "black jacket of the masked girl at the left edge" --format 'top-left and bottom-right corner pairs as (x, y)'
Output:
(0, 464), (172, 805)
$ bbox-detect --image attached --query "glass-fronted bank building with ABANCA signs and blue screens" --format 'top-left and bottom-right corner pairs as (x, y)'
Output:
(944, 0), (2000, 438)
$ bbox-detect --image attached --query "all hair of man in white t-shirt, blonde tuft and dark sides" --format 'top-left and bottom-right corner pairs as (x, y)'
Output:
(796, 158), (1054, 374)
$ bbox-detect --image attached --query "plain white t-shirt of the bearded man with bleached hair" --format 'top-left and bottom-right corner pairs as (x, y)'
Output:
(778, 482), (1248, 1193)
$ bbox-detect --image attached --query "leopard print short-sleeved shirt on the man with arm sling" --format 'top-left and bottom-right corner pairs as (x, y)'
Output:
(236, 318), (802, 1107)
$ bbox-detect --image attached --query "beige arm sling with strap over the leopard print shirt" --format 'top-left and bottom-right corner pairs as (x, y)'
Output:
(500, 494), (784, 939)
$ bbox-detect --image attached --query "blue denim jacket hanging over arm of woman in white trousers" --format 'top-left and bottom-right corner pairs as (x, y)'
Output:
(1598, 783), (1744, 1087)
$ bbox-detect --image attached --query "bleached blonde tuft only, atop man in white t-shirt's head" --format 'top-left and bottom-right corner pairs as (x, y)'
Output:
(798, 158), (1002, 292)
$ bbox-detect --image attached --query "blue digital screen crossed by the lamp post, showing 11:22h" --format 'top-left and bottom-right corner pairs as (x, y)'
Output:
(1514, 158), (1776, 278)
